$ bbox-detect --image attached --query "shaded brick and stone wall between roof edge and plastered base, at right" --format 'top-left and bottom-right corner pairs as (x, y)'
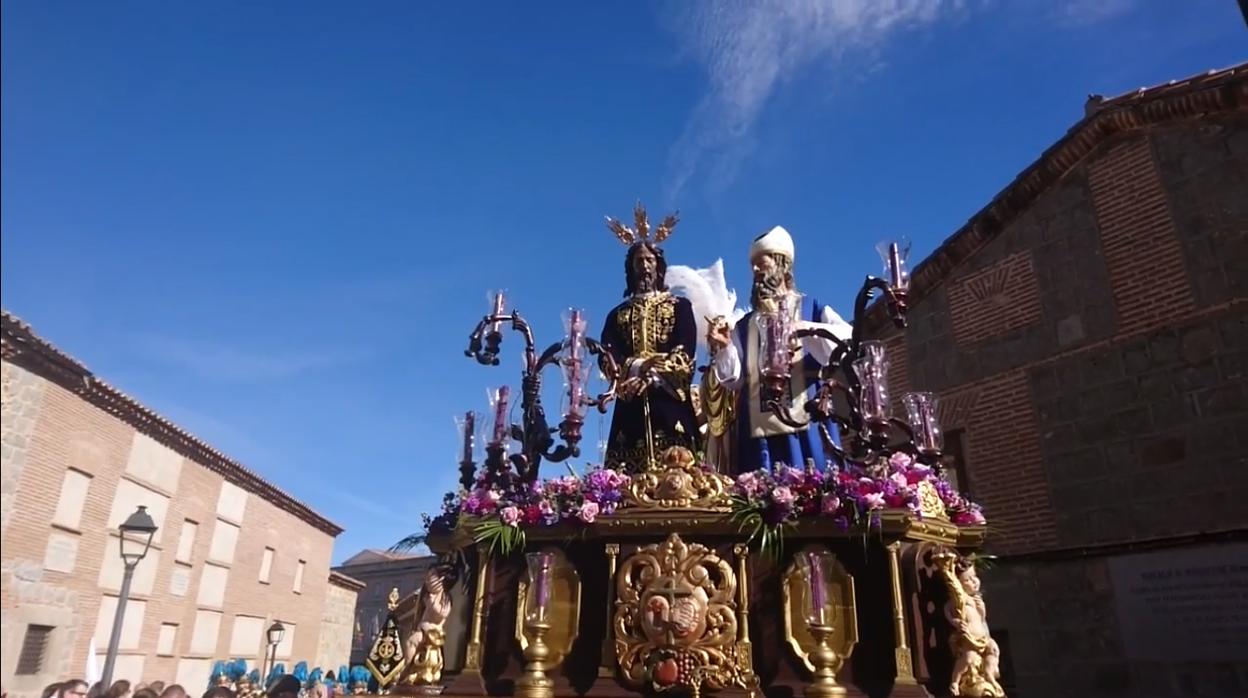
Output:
(889, 115), (1248, 553)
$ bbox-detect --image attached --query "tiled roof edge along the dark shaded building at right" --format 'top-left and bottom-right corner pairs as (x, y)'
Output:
(864, 62), (1248, 336)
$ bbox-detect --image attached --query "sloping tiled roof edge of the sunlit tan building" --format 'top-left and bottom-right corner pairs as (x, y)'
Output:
(0, 311), (342, 536)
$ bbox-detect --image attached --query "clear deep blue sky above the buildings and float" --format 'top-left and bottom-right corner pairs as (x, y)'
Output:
(0, 0), (1246, 559)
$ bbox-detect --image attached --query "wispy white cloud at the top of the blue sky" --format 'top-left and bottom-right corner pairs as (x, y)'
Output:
(666, 0), (965, 199)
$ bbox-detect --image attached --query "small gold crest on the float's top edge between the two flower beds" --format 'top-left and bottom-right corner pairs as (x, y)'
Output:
(628, 446), (733, 511)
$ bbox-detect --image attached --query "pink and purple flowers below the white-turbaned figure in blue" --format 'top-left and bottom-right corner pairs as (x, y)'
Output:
(733, 453), (985, 553)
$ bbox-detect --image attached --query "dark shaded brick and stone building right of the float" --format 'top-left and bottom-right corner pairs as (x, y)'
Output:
(869, 64), (1248, 698)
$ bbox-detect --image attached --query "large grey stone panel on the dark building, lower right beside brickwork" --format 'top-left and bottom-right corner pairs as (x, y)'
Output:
(1028, 310), (1248, 547)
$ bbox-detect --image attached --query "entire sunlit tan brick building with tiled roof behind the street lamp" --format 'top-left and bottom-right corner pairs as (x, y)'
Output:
(0, 312), (359, 697)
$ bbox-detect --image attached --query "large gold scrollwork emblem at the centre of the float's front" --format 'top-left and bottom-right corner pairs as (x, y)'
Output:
(613, 533), (749, 689)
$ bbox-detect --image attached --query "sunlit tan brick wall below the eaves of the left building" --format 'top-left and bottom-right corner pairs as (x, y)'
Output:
(2, 362), (333, 698)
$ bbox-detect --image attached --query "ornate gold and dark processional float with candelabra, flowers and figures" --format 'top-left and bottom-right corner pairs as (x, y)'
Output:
(382, 205), (1003, 698)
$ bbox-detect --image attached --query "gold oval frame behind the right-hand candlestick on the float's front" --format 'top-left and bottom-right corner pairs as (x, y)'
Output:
(781, 544), (857, 673)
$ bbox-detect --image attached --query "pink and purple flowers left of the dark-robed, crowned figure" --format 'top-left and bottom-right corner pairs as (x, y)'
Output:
(444, 467), (630, 556)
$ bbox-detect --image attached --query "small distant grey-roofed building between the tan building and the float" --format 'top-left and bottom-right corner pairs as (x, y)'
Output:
(333, 549), (434, 664)
